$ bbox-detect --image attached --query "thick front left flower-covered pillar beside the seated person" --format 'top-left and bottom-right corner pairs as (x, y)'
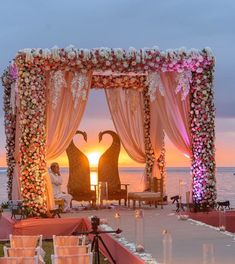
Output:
(16, 55), (47, 215)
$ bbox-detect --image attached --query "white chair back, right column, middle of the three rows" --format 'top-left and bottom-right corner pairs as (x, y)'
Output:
(54, 245), (91, 256)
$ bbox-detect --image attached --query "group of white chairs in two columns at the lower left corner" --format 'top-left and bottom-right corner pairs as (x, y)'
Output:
(0, 235), (93, 264)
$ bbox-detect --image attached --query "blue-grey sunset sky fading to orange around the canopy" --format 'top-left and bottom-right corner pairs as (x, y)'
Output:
(0, 0), (235, 167)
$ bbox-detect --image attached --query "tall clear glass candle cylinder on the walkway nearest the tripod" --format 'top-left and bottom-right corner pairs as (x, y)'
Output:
(135, 210), (144, 252)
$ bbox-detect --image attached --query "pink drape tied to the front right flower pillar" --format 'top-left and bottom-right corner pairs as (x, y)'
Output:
(151, 72), (192, 156)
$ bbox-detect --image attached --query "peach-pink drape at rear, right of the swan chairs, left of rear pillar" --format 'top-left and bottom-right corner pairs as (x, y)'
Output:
(105, 88), (145, 163)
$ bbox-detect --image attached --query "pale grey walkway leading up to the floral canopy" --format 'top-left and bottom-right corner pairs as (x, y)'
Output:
(63, 206), (235, 264)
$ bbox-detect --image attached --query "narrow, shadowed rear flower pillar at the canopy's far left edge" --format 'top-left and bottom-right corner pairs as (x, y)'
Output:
(2, 67), (16, 200)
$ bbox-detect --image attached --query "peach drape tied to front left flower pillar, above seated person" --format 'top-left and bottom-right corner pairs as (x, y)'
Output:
(45, 72), (92, 208)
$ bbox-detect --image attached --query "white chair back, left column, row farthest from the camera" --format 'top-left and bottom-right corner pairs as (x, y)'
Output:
(9, 234), (42, 248)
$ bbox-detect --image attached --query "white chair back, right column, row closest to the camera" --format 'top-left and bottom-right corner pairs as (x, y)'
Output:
(51, 253), (93, 264)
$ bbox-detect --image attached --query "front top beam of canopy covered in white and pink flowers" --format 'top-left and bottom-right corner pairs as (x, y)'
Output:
(16, 46), (213, 73)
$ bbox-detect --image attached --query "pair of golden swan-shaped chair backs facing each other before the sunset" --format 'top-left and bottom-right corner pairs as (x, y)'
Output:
(66, 130), (127, 202)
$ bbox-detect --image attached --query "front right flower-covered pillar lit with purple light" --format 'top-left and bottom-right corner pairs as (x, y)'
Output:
(190, 63), (216, 207)
